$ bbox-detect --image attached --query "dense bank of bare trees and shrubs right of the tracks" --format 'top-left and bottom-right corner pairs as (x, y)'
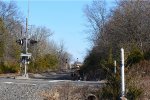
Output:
(80, 0), (150, 100)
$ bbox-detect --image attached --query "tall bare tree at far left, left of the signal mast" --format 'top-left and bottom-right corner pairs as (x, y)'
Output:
(0, 0), (22, 65)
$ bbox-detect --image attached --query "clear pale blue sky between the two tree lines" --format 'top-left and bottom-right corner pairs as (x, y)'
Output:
(9, 0), (115, 61)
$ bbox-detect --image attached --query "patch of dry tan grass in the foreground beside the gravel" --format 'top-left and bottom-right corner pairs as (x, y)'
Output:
(40, 83), (99, 100)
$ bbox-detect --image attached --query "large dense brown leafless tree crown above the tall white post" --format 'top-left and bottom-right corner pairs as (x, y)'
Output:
(105, 0), (150, 52)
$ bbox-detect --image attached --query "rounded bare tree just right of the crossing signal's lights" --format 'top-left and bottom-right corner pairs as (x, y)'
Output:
(29, 26), (53, 58)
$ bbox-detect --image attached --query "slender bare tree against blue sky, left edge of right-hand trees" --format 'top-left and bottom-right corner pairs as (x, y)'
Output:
(84, 0), (107, 44)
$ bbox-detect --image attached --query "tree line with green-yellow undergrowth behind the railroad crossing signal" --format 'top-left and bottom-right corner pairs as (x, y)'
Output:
(0, 0), (71, 73)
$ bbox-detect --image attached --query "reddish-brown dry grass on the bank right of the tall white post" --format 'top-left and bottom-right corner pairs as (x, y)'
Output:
(127, 61), (150, 100)
